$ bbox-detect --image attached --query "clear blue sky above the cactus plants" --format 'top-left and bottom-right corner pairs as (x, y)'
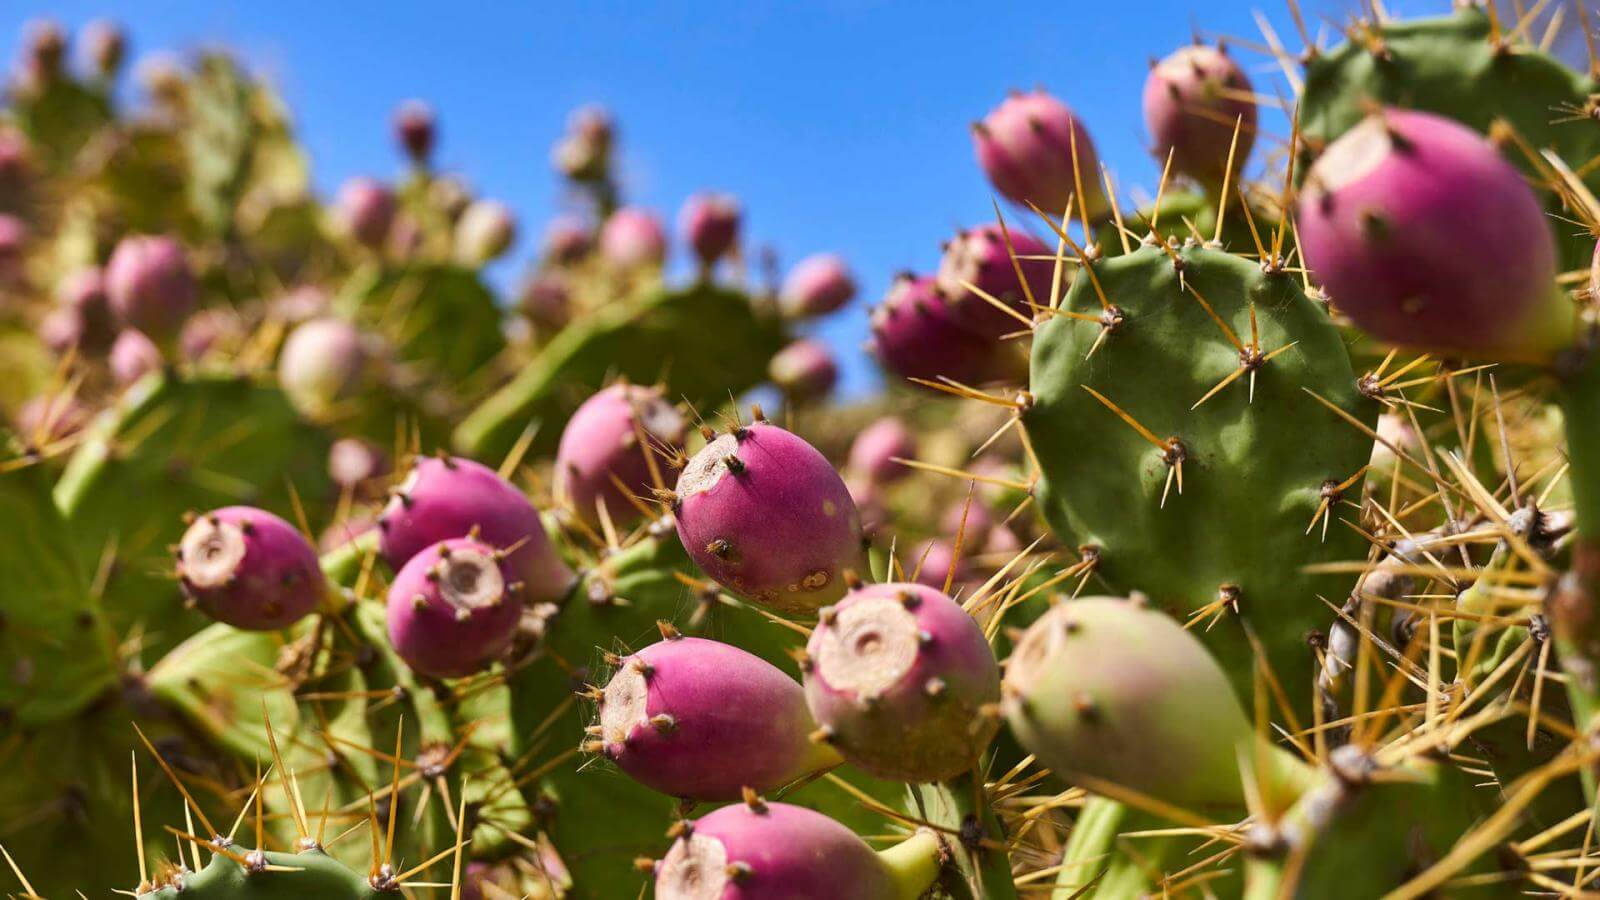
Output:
(0, 0), (1356, 392)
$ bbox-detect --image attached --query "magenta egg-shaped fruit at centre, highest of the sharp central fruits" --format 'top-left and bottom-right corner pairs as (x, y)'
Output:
(674, 421), (864, 613)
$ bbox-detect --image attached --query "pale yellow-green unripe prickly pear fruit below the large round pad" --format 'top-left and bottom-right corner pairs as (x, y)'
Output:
(1002, 597), (1306, 810)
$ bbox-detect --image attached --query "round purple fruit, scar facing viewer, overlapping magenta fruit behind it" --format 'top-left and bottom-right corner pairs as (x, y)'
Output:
(387, 538), (522, 677)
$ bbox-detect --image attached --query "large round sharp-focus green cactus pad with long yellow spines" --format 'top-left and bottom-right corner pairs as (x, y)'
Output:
(1024, 247), (1378, 697)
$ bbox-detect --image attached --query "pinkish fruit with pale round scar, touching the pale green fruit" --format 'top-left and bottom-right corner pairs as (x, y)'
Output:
(805, 585), (1000, 781)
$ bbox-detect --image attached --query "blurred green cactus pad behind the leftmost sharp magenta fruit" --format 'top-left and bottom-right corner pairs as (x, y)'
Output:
(54, 373), (331, 658)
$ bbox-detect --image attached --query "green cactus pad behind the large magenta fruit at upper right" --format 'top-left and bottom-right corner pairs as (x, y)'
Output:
(1299, 6), (1600, 269)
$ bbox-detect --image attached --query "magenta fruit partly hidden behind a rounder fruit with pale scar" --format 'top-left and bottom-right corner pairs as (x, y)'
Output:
(378, 456), (573, 604)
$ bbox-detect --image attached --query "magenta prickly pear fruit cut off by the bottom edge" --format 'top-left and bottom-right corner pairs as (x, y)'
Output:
(656, 794), (941, 900)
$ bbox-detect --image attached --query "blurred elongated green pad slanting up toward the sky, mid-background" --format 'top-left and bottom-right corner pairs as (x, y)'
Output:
(454, 283), (786, 460)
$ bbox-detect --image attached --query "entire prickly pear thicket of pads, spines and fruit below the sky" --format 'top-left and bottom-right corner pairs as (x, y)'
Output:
(0, 5), (1600, 900)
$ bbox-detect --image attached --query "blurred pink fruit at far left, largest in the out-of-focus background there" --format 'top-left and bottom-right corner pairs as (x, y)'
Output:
(106, 235), (197, 338)
